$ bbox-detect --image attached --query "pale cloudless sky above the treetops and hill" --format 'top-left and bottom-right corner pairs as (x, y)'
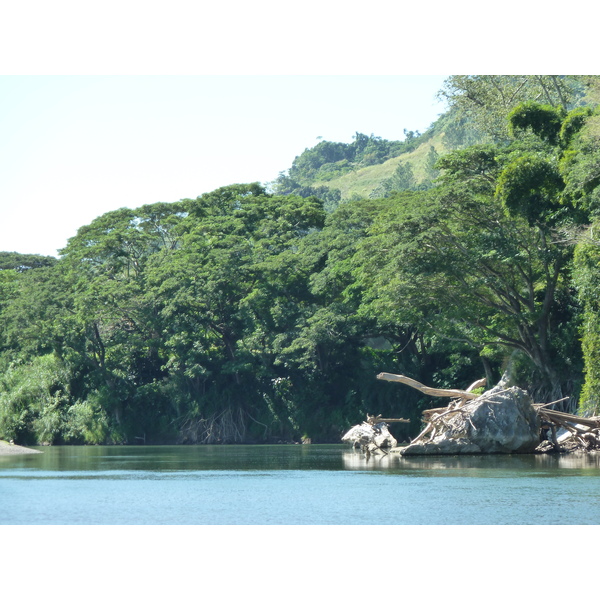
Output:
(0, 75), (446, 255)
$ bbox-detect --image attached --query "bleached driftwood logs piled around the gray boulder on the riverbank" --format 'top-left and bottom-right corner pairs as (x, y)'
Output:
(342, 373), (600, 456)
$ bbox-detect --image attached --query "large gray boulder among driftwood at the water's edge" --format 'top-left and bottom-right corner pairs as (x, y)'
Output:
(400, 387), (540, 456)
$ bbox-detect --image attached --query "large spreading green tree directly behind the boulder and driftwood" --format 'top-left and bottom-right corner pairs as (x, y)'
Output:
(356, 140), (573, 399)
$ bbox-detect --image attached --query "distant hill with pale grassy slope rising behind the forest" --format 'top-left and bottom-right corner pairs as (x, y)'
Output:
(274, 76), (585, 210)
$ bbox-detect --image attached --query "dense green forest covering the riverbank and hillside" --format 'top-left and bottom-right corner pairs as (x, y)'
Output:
(0, 75), (600, 444)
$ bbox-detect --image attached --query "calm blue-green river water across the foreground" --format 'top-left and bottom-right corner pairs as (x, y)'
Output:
(0, 445), (600, 525)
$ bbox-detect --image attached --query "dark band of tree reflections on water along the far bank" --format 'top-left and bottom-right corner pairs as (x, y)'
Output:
(0, 444), (600, 476)
